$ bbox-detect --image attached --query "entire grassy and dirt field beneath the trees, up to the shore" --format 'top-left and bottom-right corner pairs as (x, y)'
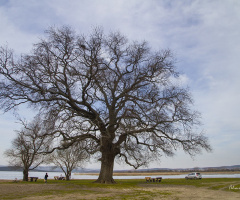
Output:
(0, 178), (240, 200)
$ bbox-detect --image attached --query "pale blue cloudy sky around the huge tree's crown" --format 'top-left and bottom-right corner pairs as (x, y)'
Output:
(0, 0), (240, 169)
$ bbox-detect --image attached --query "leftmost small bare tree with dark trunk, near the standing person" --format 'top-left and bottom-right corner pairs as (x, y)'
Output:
(4, 118), (51, 181)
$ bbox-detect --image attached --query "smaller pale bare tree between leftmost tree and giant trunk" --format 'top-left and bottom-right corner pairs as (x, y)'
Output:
(49, 142), (89, 181)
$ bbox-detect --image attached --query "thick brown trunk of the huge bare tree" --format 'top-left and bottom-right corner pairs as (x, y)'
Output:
(95, 148), (116, 184)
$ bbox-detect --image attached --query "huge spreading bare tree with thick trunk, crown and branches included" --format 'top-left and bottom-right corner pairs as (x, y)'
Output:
(0, 27), (210, 183)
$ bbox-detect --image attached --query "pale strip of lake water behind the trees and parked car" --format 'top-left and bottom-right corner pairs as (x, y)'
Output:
(0, 171), (240, 180)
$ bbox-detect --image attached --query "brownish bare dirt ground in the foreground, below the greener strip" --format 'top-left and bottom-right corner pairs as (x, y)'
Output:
(0, 183), (240, 200)
